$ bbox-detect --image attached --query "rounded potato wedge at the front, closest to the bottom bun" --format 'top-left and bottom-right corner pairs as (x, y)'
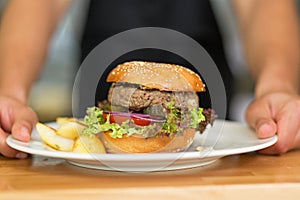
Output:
(73, 135), (106, 154)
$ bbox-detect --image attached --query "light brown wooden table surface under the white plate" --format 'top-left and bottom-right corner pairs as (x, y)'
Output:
(0, 151), (300, 200)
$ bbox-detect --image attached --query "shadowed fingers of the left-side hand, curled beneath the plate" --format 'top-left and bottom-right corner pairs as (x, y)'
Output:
(0, 128), (28, 159)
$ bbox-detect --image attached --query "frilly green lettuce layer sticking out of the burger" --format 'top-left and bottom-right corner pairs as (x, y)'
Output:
(82, 102), (205, 138)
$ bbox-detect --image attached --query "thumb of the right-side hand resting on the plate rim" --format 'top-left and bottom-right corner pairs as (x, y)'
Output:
(246, 101), (277, 138)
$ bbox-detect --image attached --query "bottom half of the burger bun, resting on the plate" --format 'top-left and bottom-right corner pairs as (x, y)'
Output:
(98, 129), (195, 153)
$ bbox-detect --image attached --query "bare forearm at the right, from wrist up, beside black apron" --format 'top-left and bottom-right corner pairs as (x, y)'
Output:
(234, 0), (300, 97)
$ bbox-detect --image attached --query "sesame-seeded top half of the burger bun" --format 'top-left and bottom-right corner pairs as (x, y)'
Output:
(106, 61), (205, 92)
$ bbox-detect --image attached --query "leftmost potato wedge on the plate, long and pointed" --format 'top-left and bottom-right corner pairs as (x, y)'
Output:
(36, 122), (74, 151)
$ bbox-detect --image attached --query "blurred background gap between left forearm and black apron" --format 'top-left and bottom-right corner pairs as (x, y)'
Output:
(25, 0), (89, 121)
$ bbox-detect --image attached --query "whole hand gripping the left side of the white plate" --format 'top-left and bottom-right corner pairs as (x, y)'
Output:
(0, 96), (37, 158)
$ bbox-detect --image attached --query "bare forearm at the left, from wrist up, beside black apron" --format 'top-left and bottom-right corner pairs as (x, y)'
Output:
(0, 0), (68, 102)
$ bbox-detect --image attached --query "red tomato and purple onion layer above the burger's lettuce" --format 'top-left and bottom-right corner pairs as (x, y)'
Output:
(103, 112), (164, 126)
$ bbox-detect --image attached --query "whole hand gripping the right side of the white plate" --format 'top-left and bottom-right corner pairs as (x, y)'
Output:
(246, 93), (300, 154)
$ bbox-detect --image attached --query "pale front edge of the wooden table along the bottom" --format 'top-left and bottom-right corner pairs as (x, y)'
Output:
(0, 183), (300, 200)
